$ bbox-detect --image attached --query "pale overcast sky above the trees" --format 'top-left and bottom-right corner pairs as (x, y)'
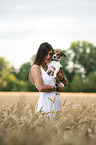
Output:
(0, 0), (96, 68)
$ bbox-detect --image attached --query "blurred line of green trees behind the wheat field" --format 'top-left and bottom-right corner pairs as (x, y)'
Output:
(0, 41), (96, 92)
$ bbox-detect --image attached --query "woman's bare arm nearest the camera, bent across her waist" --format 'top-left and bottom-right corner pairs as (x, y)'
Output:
(30, 64), (62, 92)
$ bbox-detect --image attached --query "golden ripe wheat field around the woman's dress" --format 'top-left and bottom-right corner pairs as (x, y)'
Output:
(0, 92), (96, 145)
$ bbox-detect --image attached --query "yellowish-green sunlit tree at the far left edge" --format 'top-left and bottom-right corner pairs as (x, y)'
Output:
(0, 57), (26, 91)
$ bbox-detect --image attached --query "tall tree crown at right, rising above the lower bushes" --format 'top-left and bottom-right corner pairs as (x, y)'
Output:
(69, 41), (96, 76)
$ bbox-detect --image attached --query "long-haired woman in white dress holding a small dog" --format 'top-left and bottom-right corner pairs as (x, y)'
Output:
(29, 42), (68, 117)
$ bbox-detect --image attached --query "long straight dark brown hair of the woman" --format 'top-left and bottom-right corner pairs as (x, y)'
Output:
(33, 42), (53, 65)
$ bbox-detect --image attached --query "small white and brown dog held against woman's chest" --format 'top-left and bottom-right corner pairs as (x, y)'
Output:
(47, 50), (66, 86)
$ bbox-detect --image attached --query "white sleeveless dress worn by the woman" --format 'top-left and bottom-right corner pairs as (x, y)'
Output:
(36, 66), (61, 117)
